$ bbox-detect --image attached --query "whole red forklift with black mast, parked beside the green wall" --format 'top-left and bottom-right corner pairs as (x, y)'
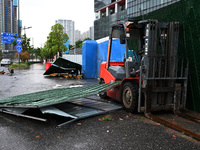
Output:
(99, 20), (188, 117)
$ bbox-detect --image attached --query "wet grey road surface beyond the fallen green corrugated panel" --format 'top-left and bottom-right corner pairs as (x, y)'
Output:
(0, 64), (98, 98)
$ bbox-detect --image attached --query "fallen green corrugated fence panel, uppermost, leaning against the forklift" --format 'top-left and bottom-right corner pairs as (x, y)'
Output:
(0, 82), (120, 107)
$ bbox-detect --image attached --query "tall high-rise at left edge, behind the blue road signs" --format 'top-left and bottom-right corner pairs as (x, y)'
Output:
(0, 0), (18, 55)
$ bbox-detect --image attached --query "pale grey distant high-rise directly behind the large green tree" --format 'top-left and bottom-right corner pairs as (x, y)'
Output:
(56, 19), (75, 45)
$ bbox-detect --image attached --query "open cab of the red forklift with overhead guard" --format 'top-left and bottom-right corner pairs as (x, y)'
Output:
(107, 22), (143, 81)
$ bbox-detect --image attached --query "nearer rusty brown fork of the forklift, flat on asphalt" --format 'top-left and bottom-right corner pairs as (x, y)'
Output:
(148, 114), (200, 141)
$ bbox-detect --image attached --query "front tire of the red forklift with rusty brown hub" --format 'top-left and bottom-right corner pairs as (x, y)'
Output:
(121, 82), (138, 113)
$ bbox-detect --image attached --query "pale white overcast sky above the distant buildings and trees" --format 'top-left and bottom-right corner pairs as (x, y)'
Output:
(20, 0), (95, 48)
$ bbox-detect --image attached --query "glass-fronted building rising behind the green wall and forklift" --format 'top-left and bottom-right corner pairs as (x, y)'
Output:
(94, 0), (180, 40)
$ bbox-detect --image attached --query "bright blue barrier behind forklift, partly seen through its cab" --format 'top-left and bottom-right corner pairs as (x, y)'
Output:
(82, 39), (126, 78)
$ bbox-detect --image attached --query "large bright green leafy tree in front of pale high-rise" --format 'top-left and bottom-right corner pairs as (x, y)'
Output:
(41, 23), (69, 59)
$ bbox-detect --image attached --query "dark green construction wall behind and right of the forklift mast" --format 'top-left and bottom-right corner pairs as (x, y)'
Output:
(133, 0), (200, 112)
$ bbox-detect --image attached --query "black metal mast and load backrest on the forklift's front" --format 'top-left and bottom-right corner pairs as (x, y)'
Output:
(138, 21), (188, 116)
